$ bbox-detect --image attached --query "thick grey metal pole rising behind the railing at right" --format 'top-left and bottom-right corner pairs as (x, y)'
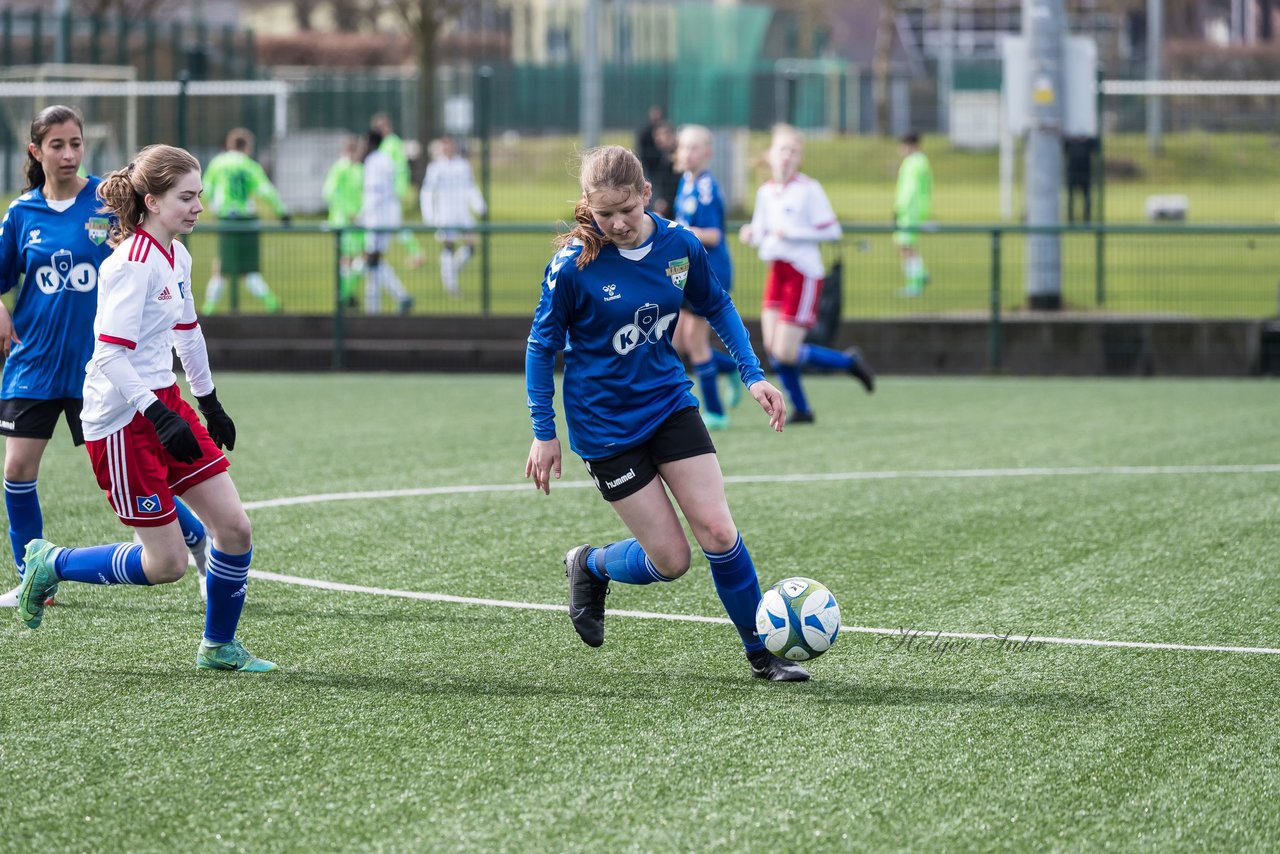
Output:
(1023, 0), (1064, 310)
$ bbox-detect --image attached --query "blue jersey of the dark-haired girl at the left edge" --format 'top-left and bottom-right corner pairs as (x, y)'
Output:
(0, 177), (111, 401)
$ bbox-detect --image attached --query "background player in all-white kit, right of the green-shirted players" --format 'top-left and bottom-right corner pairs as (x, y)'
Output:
(419, 137), (485, 294)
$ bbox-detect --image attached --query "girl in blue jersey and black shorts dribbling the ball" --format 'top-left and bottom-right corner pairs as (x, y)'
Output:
(525, 146), (809, 681)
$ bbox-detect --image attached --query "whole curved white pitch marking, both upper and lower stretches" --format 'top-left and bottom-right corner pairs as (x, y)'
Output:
(244, 463), (1280, 656)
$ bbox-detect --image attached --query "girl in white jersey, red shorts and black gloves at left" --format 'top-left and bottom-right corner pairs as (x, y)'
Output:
(18, 145), (275, 672)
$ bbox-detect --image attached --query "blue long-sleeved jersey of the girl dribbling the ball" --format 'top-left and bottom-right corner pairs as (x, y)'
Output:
(525, 214), (764, 460)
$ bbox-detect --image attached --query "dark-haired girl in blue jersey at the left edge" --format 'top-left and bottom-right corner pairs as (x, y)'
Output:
(0, 105), (206, 608)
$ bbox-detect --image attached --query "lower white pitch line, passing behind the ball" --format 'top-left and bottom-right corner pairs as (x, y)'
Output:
(250, 570), (1280, 656)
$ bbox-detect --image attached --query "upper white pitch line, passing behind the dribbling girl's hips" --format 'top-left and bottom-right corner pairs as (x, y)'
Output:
(244, 463), (1280, 510)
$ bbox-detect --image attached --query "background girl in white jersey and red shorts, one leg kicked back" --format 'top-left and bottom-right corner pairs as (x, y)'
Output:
(739, 124), (876, 424)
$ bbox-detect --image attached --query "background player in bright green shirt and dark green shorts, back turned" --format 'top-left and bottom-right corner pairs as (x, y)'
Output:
(204, 128), (289, 314)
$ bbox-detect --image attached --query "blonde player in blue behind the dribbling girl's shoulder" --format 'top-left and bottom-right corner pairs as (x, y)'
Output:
(675, 124), (742, 430)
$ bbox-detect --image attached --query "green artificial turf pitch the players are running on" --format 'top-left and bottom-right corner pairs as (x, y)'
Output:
(0, 376), (1280, 851)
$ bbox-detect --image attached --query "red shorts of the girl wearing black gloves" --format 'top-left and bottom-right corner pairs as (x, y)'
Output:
(84, 385), (230, 528)
